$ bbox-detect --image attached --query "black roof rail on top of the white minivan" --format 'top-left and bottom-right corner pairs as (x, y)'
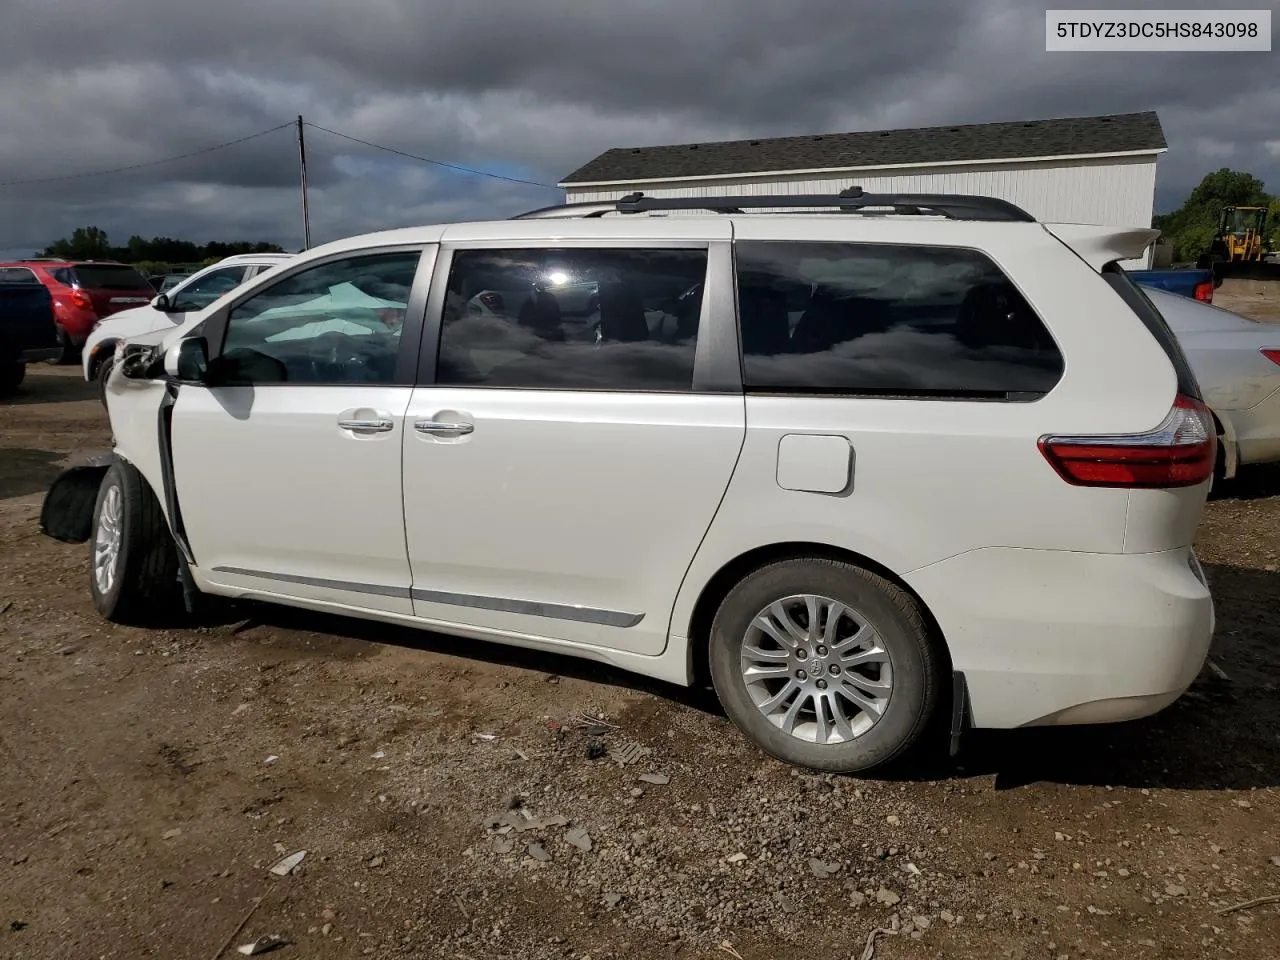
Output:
(512, 187), (1036, 223)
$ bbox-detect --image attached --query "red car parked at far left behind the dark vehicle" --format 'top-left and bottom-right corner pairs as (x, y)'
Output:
(0, 259), (155, 364)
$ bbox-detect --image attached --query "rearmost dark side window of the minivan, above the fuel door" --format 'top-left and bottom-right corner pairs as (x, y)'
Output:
(736, 241), (1062, 401)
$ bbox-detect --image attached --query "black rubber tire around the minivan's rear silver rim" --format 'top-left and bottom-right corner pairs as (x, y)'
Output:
(709, 558), (945, 773)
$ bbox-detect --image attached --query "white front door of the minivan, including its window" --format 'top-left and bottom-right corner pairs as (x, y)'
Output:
(173, 248), (434, 613)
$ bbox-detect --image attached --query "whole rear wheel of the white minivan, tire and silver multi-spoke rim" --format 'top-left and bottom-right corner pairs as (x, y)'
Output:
(709, 558), (943, 773)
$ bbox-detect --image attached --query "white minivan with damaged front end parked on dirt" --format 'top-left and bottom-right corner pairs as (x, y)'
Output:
(42, 188), (1216, 771)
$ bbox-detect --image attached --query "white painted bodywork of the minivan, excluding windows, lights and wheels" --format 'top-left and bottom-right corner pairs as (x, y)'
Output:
(108, 208), (1213, 742)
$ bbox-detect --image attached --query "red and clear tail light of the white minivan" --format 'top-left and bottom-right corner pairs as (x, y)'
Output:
(1039, 394), (1217, 488)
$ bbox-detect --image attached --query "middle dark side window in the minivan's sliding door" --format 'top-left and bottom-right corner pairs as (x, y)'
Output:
(436, 248), (707, 392)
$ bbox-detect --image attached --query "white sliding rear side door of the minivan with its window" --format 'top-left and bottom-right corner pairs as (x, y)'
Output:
(404, 242), (745, 655)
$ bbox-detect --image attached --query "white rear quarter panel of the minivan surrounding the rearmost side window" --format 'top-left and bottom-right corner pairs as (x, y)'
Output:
(672, 218), (1177, 636)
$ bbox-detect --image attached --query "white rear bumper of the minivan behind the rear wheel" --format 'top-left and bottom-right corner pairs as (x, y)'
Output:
(906, 548), (1213, 727)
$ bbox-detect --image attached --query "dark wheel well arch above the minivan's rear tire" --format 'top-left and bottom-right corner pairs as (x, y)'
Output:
(689, 541), (951, 686)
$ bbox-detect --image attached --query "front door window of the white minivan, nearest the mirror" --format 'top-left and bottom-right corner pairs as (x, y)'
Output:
(219, 251), (420, 384)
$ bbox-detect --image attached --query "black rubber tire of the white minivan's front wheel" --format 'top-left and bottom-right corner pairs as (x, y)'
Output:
(88, 460), (182, 625)
